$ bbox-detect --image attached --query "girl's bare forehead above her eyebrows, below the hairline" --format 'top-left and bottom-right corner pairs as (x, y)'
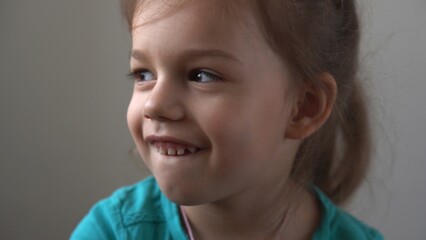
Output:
(132, 0), (264, 53)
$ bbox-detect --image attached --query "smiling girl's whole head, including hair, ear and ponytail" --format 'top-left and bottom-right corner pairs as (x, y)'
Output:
(122, 0), (369, 204)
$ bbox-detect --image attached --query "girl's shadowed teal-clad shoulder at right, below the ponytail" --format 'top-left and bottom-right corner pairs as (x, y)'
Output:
(313, 188), (383, 240)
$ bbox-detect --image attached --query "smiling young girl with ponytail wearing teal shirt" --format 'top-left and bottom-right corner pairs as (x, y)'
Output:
(71, 0), (382, 240)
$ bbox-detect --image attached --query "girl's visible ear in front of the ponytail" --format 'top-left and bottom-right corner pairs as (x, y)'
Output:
(286, 73), (337, 139)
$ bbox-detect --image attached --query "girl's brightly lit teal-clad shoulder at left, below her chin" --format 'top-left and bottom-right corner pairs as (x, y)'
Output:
(71, 177), (185, 240)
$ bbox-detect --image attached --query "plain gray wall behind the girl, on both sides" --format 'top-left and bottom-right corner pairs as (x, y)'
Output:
(0, 0), (426, 239)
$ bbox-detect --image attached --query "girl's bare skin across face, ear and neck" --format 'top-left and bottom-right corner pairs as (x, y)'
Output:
(127, 0), (336, 240)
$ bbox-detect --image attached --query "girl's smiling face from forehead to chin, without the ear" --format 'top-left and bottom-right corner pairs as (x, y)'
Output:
(127, 1), (298, 205)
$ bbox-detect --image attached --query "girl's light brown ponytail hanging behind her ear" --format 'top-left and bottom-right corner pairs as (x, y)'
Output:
(307, 81), (371, 204)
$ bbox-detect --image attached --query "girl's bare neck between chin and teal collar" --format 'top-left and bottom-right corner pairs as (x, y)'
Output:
(183, 181), (320, 240)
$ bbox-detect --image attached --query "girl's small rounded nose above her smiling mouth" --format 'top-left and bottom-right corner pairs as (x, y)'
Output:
(143, 80), (185, 121)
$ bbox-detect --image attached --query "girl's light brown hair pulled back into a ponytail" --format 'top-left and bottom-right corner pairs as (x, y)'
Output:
(121, 0), (371, 204)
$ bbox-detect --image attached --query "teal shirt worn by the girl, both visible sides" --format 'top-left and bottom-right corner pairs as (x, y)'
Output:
(70, 177), (383, 240)
